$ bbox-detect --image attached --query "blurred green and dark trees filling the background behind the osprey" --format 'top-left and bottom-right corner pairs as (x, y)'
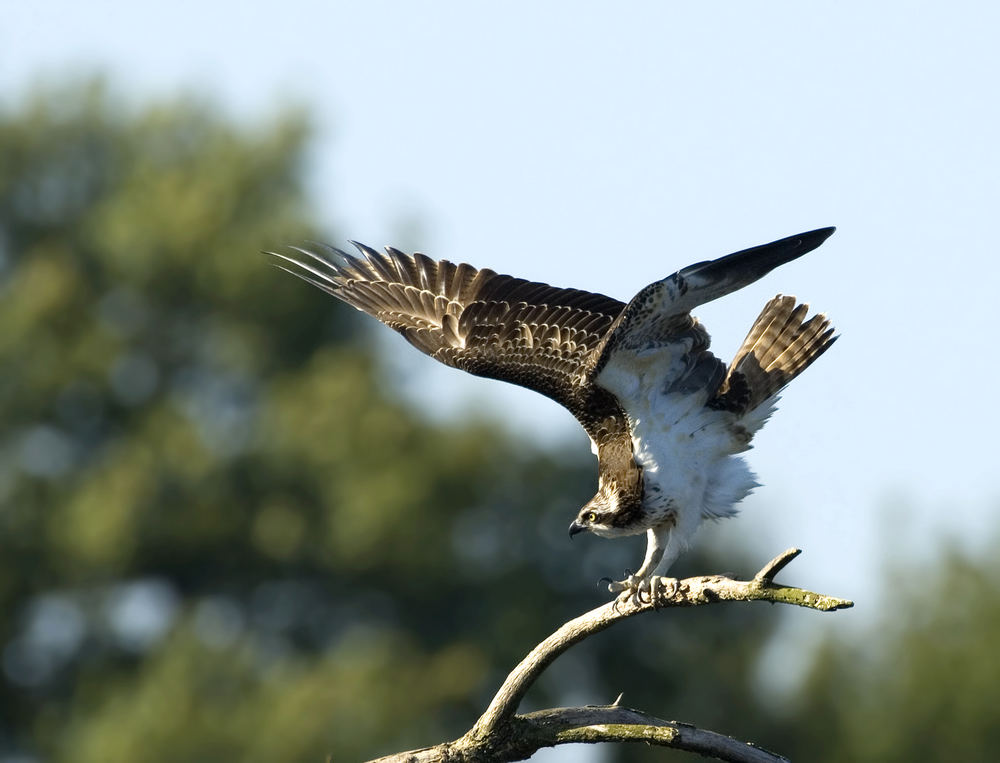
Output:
(0, 83), (1000, 761)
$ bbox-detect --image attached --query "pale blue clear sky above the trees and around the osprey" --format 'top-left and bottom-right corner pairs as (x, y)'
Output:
(7, 0), (1000, 656)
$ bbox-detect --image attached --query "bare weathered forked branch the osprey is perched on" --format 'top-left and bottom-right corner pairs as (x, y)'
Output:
(368, 548), (854, 763)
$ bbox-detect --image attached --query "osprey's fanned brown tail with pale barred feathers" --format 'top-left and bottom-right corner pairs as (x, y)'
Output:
(709, 294), (837, 413)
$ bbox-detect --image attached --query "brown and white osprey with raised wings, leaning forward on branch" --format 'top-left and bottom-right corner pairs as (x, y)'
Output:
(269, 228), (836, 601)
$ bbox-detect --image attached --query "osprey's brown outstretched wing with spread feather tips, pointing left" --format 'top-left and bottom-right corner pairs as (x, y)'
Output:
(269, 242), (625, 425)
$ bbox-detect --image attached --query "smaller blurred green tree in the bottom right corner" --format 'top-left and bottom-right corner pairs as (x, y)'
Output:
(762, 542), (1000, 763)
